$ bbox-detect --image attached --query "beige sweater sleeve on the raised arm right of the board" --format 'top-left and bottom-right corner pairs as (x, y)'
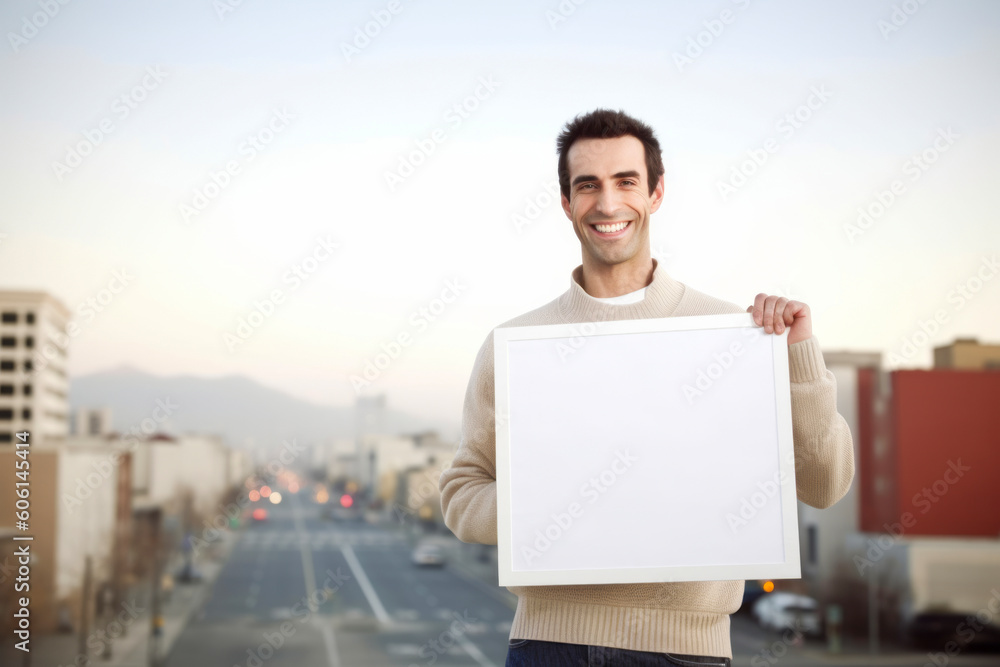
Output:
(788, 336), (854, 509)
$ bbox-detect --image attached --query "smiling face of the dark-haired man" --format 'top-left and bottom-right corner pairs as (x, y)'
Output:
(562, 136), (663, 268)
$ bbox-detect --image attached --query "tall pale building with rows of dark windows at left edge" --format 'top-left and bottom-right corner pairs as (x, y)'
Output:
(0, 291), (70, 447)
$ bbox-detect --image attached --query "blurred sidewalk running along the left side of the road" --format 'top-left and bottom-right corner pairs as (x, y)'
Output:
(0, 530), (240, 667)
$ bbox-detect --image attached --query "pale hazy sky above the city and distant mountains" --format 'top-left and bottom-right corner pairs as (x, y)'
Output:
(0, 0), (1000, 430)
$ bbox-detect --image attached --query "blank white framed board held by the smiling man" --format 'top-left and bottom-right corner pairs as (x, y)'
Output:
(494, 314), (800, 586)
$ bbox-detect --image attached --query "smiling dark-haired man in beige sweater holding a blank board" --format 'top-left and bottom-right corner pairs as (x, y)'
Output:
(440, 109), (854, 666)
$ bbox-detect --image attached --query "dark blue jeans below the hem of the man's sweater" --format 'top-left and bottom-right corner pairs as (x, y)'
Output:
(505, 639), (732, 667)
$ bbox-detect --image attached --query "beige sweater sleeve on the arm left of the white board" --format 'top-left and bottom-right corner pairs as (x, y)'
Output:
(439, 333), (497, 544)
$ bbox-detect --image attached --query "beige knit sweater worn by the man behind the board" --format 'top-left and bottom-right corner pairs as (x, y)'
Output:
(440, 260), (854, 658)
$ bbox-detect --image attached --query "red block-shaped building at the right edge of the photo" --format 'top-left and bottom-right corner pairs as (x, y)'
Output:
(859, 369), (1000, 538)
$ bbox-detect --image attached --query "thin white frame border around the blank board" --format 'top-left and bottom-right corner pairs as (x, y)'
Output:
(494, 313), (801, 586)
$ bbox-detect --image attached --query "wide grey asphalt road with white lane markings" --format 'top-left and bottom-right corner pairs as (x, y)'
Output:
(167, 496), (514, 667)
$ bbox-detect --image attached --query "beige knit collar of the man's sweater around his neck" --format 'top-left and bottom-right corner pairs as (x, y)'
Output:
(559, 258), (684, 322)
